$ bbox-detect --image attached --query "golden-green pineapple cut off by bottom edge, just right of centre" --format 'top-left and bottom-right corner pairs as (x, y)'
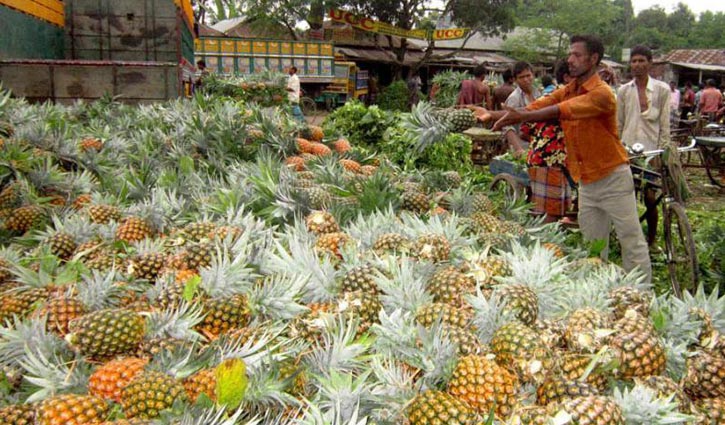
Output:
(407, 390), (480, 425)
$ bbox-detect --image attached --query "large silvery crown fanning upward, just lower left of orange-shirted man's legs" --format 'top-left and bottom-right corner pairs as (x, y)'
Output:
(498, 242), (566, 319)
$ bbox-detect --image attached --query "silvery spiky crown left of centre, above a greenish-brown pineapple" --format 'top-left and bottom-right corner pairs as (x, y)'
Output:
(199, 243), (259, 298)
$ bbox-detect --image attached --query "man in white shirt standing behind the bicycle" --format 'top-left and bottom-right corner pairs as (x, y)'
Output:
(617, 46), (671, 246)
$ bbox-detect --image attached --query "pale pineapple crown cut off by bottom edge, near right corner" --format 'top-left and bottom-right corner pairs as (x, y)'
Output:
(613, 384), (695, 425)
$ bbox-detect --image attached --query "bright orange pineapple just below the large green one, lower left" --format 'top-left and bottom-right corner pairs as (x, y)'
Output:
(88, 357), (148, 403)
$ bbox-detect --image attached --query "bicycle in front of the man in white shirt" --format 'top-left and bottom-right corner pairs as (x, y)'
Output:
(630, 139), (699, 298)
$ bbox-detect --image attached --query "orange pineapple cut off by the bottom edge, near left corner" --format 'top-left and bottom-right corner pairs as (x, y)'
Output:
(35, 394), (109, 425)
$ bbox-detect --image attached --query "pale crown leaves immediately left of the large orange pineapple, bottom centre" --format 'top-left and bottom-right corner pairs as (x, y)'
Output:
(372, 310), (458, 387)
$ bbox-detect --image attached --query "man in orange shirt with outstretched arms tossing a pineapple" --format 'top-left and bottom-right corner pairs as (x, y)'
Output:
(476, 36), (652, 282)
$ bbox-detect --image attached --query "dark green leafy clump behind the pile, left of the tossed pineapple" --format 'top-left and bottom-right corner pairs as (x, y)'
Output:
(322, 100), (400, 146)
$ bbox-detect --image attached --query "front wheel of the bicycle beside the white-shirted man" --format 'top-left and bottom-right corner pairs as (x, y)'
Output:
(664, 202), (698, 297)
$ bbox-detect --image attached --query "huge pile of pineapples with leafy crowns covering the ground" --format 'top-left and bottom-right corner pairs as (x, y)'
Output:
(0, 87), (725, 425)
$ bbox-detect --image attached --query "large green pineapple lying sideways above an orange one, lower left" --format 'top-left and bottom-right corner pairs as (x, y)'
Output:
(68, 309), (144, 359)
